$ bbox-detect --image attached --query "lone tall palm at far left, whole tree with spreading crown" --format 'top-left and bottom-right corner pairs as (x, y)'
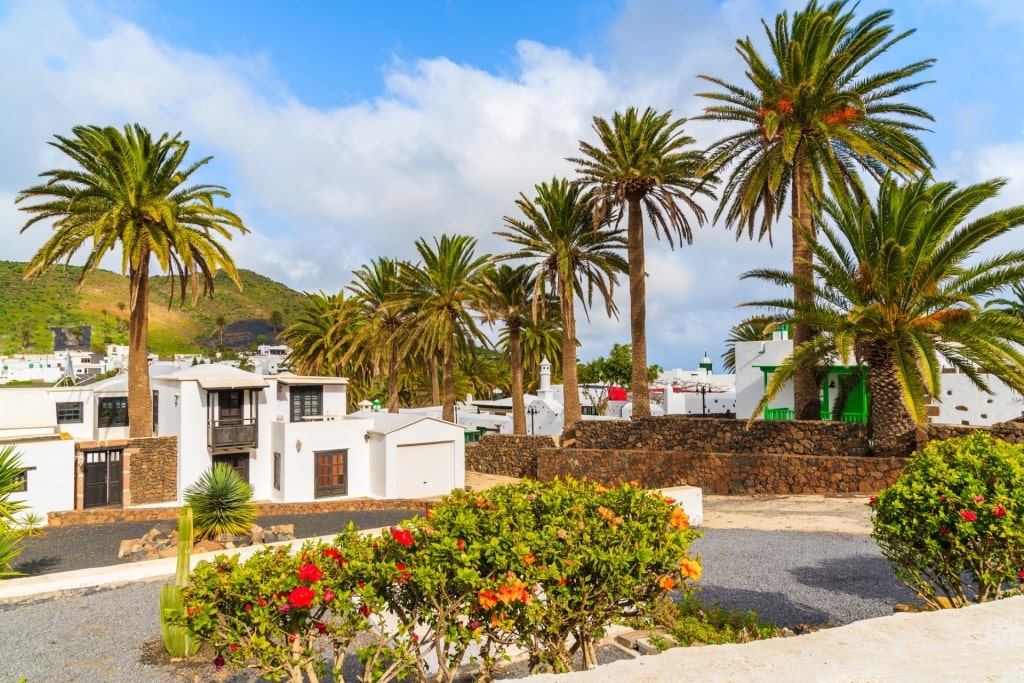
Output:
(15, 124), (248, 437)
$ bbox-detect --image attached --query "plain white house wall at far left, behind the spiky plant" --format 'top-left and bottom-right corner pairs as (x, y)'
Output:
(0, 429), (75, 517)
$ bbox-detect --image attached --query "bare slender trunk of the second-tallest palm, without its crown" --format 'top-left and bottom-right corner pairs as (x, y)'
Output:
(622, 199), (650, 420)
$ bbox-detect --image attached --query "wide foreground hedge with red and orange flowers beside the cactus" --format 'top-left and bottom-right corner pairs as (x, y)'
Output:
(177, 480), (700, 682)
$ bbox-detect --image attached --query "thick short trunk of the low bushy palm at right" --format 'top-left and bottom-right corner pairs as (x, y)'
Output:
(860, 343), (918, 457)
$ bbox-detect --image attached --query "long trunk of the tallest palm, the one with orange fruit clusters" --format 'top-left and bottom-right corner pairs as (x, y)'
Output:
(793, 153), (821, 420)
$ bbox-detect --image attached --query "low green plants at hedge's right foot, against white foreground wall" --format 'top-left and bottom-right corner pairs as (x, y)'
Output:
(654, 595), (778, 645)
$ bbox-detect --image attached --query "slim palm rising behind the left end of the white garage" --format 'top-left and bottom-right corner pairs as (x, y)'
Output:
(348, 258), (411, 413)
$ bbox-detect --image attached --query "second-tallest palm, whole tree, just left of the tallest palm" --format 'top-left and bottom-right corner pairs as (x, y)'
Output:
(568, 106), (715, 418)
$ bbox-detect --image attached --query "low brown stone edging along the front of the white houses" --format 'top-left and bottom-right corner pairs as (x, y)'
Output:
(47, 498), (435, 526)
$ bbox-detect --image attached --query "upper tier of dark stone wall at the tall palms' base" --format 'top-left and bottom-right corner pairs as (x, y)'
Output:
(577, 416), (868, 456)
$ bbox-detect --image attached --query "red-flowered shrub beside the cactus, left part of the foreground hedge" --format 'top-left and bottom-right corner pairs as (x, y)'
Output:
(175, 526), (368, 681)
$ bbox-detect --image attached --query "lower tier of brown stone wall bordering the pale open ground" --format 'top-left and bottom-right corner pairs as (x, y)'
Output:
(537, 449), (906, 495)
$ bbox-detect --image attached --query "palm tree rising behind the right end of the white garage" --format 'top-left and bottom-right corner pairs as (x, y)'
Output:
(396, 234), (489, 422)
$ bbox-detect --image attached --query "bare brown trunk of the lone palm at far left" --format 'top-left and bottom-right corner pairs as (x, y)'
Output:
(128, 248), (153, 438)
